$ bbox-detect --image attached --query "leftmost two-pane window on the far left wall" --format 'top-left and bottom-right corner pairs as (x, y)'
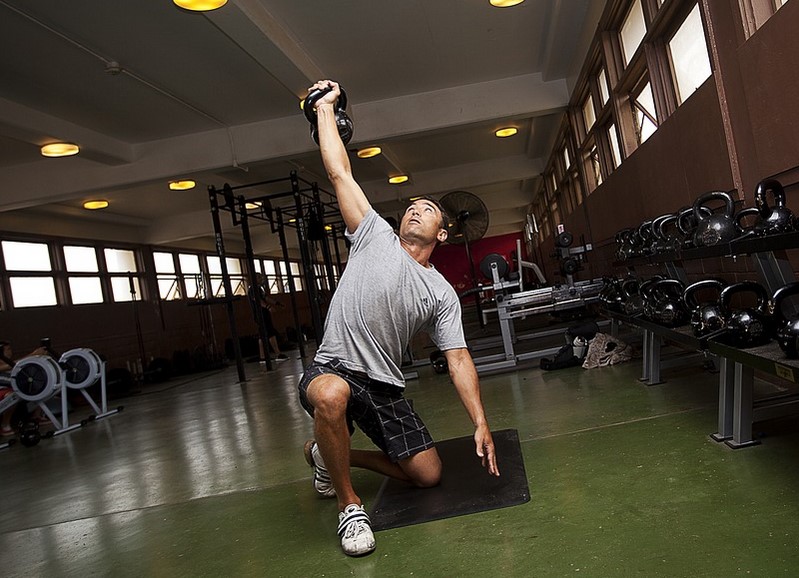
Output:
(2, 241), (58, 307)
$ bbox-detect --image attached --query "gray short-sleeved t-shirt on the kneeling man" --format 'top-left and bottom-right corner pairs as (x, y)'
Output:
(314, 209), (466, 387)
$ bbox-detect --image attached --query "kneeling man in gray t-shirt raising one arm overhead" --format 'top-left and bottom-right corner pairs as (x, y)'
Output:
(299, 80), (499, 556)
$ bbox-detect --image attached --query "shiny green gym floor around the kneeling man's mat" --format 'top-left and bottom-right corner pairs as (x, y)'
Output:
(0, 340), (799, 578)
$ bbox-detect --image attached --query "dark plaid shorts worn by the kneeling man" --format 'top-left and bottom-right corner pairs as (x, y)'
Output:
(298, 359), (434, 462)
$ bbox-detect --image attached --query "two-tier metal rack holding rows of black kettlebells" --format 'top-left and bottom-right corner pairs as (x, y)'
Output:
(604, 232), (799, 449)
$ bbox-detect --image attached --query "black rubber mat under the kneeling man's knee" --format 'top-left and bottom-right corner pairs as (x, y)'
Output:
(369, 429), (530, 531)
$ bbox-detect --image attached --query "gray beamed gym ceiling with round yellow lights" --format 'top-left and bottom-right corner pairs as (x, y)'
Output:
(0, 0), (605, 254)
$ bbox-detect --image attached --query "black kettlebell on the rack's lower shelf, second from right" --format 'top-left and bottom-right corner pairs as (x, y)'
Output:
(719, 281), (774, 348)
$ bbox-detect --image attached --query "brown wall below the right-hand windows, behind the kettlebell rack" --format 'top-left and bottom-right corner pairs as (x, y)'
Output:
(566, 0), (799, 280)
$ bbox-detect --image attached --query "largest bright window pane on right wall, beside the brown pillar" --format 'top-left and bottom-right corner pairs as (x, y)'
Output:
(668, 4), (711, 103)
